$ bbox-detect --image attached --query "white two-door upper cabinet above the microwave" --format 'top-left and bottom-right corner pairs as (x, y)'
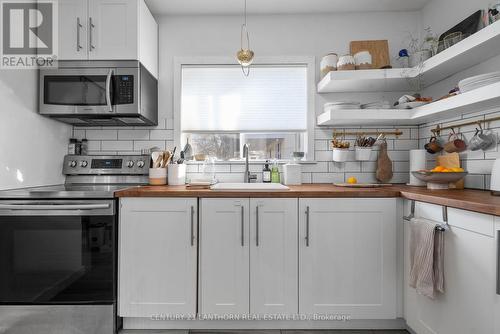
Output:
(59, 0), (158, 77)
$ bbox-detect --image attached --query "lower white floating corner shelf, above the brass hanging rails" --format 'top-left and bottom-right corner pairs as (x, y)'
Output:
(317, 82), (500, 126)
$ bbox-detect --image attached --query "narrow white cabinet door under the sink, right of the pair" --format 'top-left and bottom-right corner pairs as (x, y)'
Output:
(250, 198), (298, 314)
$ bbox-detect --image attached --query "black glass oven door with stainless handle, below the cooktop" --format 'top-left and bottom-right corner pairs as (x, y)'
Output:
(0, 200), (117, 305)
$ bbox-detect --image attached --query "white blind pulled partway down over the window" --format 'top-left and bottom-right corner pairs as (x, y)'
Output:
(181, 65), (307, 131)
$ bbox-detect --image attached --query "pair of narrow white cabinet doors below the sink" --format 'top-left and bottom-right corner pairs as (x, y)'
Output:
(199, 198), (298, 315)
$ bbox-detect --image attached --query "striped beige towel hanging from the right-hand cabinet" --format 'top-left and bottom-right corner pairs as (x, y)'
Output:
(410, 218), (444, 299)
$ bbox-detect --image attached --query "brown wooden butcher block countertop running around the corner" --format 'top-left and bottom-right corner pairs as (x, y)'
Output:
(115, 184), (500, 216)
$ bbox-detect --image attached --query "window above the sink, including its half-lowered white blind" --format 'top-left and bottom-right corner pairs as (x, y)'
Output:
(180, 64), (309, 161)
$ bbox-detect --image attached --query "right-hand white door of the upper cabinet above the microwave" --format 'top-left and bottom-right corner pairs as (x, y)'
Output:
(88, 0), (138, 60)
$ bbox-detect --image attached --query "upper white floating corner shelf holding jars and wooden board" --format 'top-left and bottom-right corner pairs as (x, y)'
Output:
(318, 22), (500, 93)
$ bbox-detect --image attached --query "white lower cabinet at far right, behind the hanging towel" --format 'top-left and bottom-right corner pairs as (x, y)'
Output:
(404, 202), (500, 334)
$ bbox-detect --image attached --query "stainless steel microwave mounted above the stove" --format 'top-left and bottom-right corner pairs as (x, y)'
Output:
(39, 61), (158, 126)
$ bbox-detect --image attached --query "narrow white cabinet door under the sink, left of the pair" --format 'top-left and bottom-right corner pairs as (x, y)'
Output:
(200, 198), (250, 315)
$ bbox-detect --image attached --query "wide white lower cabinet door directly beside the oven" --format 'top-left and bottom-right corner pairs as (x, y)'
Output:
(118, 198), (197, 317)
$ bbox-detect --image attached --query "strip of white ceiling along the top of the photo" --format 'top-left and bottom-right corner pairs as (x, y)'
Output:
(146, 0), (429, 15)
